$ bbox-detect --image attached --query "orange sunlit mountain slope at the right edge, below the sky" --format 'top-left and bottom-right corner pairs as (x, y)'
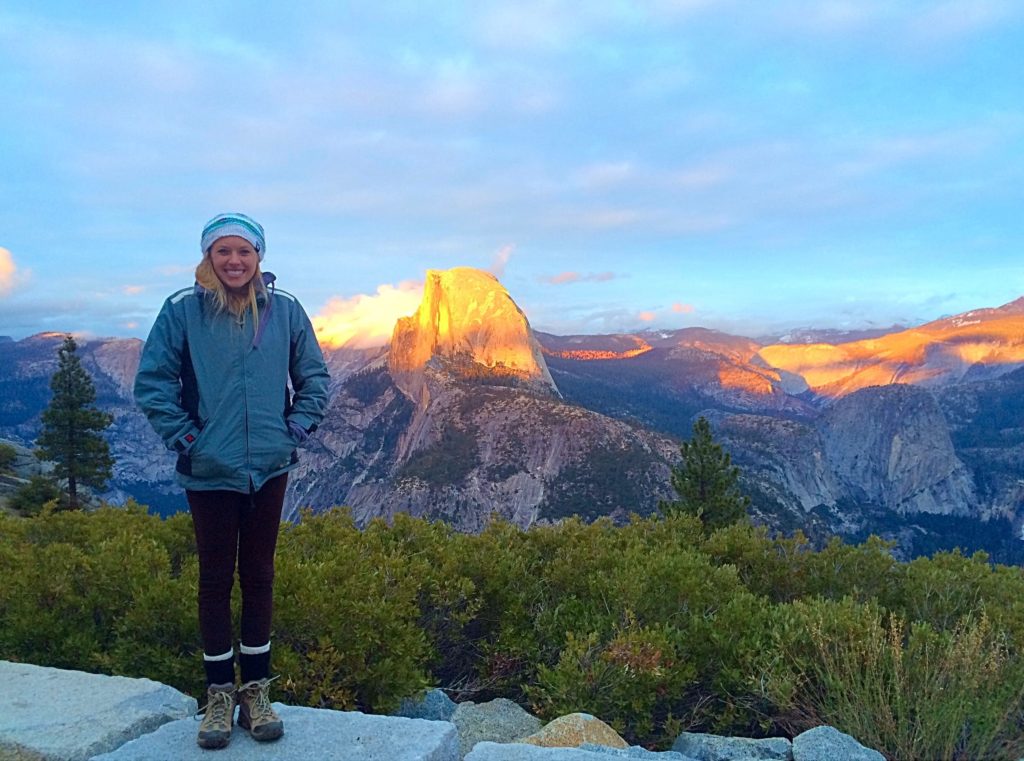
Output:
(758, 310), (1024, 396)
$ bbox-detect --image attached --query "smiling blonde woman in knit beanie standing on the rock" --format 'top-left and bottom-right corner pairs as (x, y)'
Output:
(135, 214), (328, 748)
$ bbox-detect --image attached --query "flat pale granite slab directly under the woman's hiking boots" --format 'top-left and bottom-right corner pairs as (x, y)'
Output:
(93, 703), (461, 761)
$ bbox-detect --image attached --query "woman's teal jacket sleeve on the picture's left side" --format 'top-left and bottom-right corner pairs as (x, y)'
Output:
(135, 299), (199, 453)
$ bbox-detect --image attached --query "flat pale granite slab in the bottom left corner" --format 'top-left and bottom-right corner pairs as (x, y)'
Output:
(0, 661), (197, 761)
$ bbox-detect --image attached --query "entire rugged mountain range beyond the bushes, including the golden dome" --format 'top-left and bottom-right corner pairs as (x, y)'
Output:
(0, 268), (1024, 560)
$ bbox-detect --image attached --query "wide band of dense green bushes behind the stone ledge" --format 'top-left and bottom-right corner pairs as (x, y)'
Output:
(6, 505), (1024, 759)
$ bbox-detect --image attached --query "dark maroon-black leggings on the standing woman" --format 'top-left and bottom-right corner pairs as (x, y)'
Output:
(185, 473), (288, 656)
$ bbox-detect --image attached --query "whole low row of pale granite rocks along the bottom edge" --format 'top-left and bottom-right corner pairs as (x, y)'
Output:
(0, 661), (882, 761)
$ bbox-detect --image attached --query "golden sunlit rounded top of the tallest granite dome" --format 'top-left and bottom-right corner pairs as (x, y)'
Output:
(388, 267), (557, 401)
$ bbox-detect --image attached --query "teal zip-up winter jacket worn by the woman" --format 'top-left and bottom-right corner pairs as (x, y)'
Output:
(135, 273), (329, 493)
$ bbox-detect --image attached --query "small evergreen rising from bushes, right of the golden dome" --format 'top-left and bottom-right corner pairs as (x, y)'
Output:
(657, 417), (751, 532)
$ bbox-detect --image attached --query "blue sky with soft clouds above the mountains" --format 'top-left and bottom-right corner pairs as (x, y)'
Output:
(0, 0), (1024, 342)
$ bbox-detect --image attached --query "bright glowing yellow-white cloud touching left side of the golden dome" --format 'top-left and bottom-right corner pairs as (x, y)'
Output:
(312, 281), (423, 348)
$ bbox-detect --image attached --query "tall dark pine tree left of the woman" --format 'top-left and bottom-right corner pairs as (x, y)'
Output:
(36, 336), (114, 510)
